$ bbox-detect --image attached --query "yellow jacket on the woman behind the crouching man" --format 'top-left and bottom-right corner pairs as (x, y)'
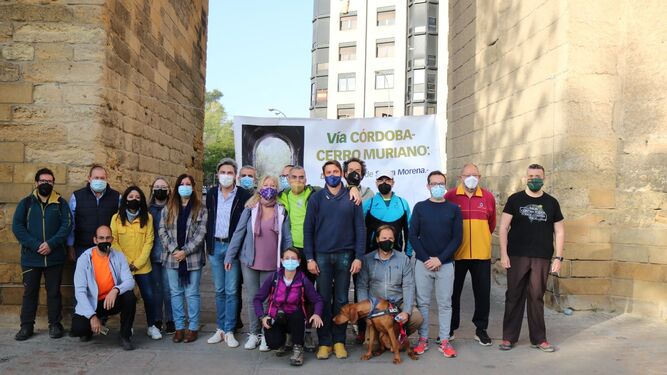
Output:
(111, 214), (154, 275)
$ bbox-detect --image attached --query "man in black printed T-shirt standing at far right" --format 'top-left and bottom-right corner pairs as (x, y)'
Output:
(500, 164), (565, 352)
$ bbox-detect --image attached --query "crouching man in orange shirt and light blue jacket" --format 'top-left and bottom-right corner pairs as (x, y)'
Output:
(72, 225), (137, 350)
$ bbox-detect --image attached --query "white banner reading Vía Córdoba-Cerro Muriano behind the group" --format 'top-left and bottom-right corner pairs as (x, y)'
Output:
(234, 115), (443, 206)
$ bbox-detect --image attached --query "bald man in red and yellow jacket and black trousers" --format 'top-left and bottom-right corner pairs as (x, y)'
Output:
(445, 163), (496, 346)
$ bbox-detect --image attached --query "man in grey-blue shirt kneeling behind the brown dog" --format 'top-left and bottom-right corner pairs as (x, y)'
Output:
(340, 225), (423, 362)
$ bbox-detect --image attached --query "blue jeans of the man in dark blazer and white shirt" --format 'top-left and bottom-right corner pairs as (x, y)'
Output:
(208, 241), (241, 332)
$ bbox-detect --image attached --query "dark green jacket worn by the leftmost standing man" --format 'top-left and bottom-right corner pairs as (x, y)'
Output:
(12, 190), (72, 267)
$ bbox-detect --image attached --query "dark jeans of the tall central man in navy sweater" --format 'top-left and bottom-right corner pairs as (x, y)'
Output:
(315, 250), (354, 346)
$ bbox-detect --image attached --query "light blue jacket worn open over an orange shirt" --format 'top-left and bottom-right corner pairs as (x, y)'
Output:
(74, 247), (134, 319)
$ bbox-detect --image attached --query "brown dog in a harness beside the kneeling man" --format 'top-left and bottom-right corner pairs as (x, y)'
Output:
(333, 299), (417, 364)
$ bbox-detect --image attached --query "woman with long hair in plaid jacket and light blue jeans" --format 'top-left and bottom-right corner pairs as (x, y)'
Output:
(160, 174), (208, 342)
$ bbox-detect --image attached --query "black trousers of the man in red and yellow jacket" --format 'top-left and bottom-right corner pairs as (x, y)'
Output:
(450, 259), (491, 332)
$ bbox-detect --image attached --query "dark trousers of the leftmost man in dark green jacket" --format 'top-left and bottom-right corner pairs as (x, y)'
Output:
(21, 264), (63, 326)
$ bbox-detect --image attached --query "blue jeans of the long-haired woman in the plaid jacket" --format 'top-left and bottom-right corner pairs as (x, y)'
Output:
(166, 268), (201, 331)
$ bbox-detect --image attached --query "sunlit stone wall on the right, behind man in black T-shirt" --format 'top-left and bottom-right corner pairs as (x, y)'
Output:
(447, 0), (667, 319)
